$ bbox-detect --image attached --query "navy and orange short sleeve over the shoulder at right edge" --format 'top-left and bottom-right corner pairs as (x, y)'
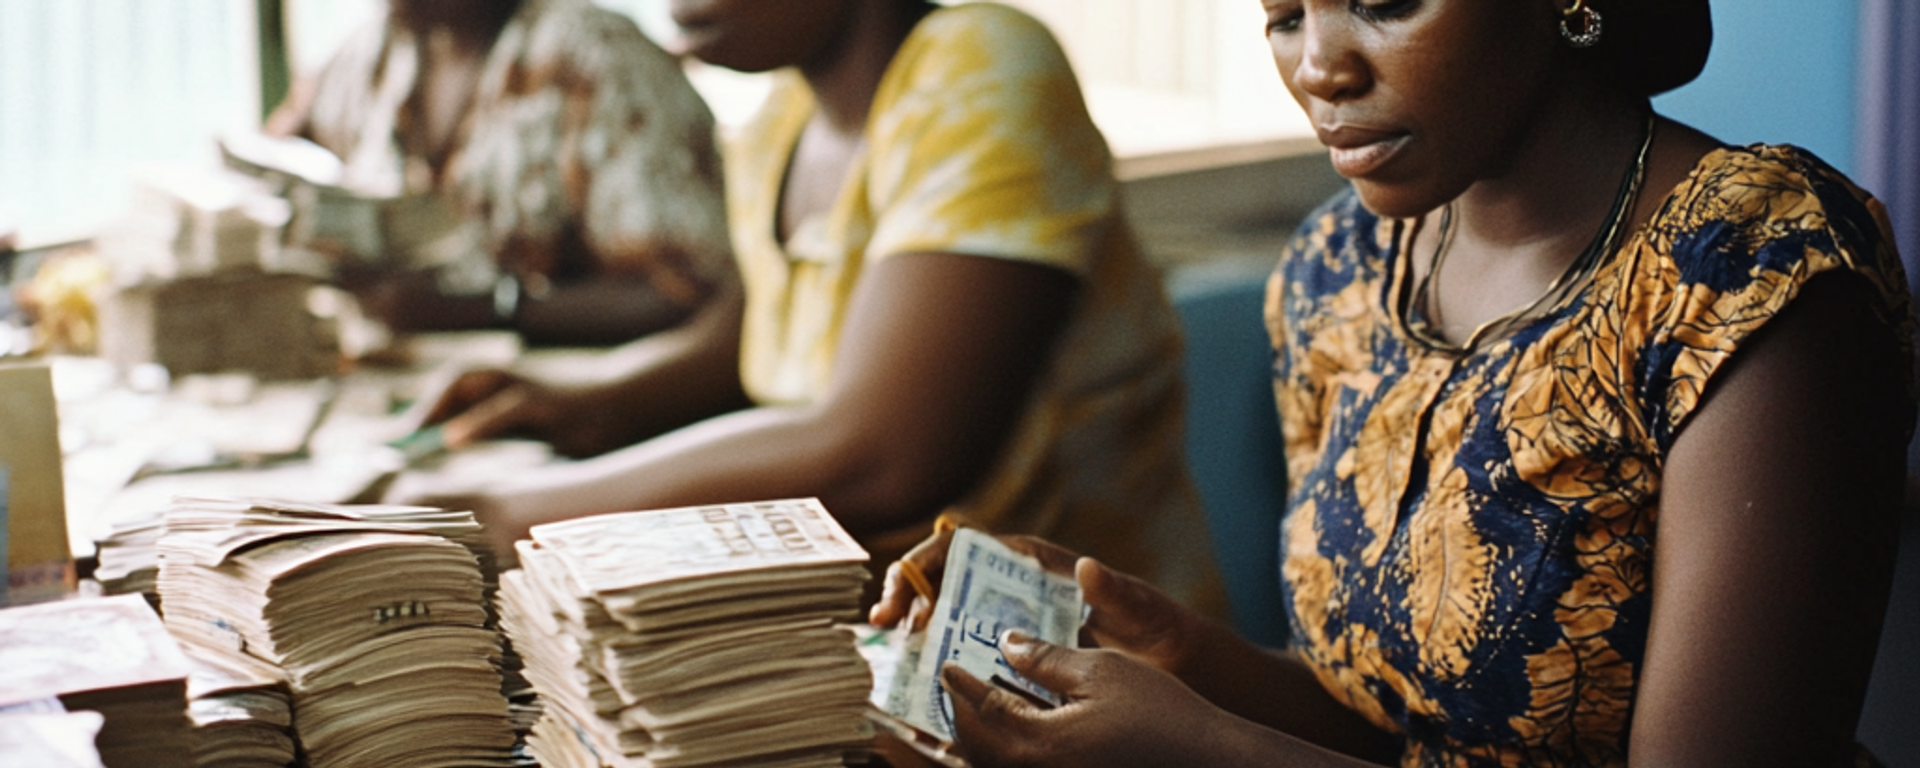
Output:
(1638, 146), (1912, 451)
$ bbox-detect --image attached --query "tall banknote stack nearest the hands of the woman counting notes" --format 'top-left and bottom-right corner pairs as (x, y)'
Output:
(501, 499), (872, 768)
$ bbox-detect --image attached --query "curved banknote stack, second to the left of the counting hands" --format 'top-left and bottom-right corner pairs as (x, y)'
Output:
(159, 499), (520, 768)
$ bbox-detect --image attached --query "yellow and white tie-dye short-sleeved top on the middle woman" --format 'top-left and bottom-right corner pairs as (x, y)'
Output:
(726, 4), (1221, 611)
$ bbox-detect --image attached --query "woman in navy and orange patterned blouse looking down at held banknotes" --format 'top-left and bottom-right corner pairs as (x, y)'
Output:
(872, 0), (1914, 768)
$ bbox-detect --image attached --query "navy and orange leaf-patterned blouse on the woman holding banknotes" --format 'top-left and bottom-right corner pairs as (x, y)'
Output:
(1267, 146), (1908, 766)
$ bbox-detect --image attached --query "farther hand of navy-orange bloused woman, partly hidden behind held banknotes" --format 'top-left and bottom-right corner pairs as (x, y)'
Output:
(868, 532), (1231, 676)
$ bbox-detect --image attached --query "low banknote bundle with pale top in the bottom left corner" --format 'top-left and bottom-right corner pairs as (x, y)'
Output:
(0, 595), (194, 768)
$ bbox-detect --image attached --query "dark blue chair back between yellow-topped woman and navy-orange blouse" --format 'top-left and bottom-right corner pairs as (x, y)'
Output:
(1171, 271), (1286, 647)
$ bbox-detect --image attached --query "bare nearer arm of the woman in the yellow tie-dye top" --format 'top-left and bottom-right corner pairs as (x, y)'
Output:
(397, 253), (1077, 560)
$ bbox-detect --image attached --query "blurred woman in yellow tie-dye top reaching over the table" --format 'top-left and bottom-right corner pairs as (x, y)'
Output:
(407, 0), (1221, 611)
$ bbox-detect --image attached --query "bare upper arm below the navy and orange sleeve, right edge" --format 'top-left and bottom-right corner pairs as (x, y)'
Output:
(1630, 275), (1907, 766)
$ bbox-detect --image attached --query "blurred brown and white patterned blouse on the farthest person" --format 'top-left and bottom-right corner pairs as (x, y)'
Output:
(296, 0), (733, 305)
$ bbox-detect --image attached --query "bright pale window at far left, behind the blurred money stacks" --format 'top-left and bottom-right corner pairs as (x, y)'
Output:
(0, 0), (259, 244)
